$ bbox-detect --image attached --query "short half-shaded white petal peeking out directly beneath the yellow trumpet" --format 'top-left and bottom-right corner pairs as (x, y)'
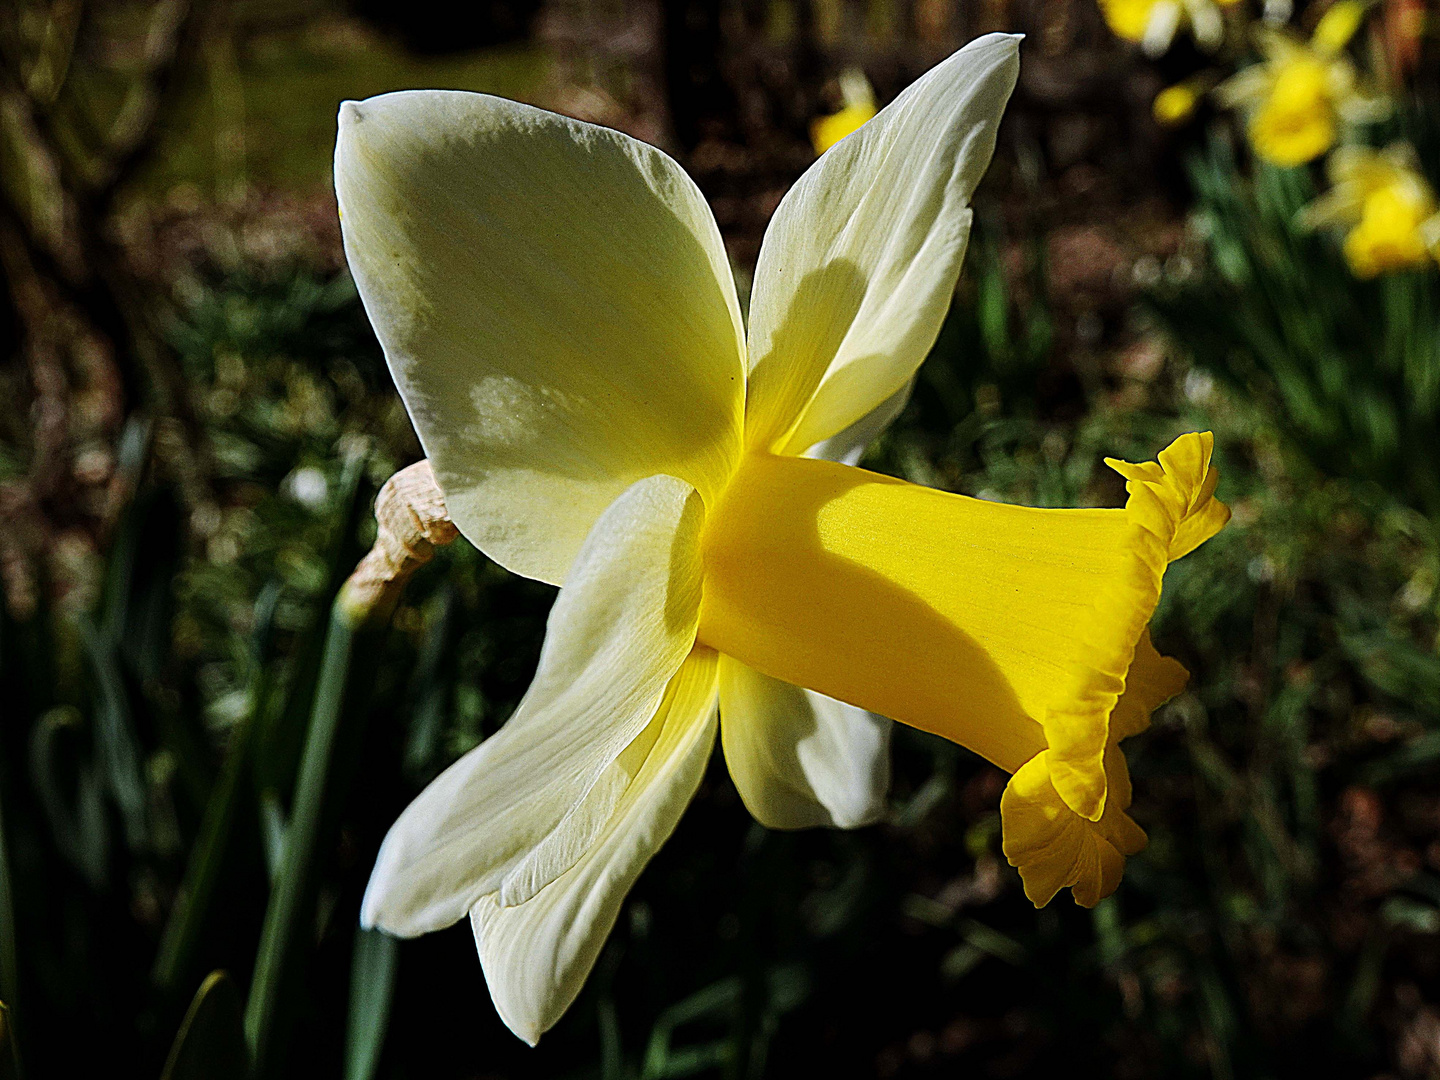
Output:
(720, 655), (891, 829)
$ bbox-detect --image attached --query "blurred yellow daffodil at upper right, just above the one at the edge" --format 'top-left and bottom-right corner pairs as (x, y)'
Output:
(1217, 0), (1390, 167)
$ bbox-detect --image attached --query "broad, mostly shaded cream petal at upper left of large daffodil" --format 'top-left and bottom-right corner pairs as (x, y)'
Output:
(336, 91), (744, 583)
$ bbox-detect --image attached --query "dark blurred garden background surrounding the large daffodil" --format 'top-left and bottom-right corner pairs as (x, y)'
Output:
(8, 0), (1440, 1080)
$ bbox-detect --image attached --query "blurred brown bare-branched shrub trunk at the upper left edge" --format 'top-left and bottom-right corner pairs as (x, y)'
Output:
(0, 0), (217, 618)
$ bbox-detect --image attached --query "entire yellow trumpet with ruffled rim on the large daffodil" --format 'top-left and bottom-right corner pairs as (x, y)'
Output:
(700, 435), (1228, 904)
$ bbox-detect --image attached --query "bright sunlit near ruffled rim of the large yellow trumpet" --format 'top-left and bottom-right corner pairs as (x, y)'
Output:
(1042, 432), (1230, 822)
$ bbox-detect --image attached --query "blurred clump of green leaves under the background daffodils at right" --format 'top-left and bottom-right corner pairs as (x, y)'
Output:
(1151, 135), (1440, 517)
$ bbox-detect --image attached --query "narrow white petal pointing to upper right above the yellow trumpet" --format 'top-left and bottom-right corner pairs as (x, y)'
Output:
(746, 33), (1020, 454)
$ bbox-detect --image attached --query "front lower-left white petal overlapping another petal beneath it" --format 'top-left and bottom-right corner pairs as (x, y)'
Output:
(360, 477), (703, 937)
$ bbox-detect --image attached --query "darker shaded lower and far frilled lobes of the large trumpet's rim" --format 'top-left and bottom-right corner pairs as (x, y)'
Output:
(999, 629), (1188, 907)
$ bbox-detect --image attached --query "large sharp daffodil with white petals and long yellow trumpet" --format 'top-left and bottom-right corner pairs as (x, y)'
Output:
(336, 35), (1227, 1043)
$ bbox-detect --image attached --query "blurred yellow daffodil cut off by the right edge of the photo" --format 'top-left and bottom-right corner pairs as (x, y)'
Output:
(1300, 144), (1440, 278)
